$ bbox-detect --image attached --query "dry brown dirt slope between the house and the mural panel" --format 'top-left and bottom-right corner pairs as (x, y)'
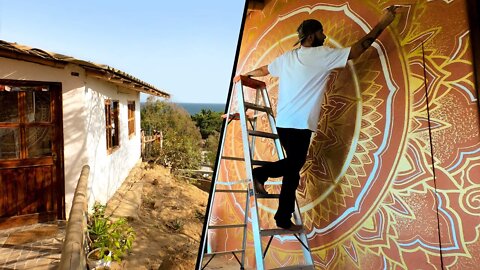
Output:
(121, 165), (209, 270)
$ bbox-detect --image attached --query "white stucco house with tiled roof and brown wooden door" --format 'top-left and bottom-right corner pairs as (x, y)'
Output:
(0, 40), (169, 228)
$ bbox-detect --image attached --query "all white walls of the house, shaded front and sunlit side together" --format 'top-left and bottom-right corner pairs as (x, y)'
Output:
(0, 57), (140, 218)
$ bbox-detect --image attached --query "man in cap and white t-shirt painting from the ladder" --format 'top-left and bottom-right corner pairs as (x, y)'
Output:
(245, 6), (397, 231)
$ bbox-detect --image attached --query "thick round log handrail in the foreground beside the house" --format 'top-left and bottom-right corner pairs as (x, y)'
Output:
(58, 165), (90, 270)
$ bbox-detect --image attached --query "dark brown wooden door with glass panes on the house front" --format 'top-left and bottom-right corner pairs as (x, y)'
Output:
(0, 80), (65, 229)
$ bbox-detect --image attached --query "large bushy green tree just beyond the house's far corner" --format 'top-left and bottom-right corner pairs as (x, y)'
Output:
(141, 98), (202, 171)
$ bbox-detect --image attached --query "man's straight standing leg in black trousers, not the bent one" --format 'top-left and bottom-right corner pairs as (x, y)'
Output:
(275, 129), (312, 229)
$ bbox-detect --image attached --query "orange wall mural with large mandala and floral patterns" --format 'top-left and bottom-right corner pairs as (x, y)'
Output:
(209, 0), (480, 269)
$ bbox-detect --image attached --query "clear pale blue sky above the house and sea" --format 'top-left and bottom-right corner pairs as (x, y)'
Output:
(0, 0), (245, 103)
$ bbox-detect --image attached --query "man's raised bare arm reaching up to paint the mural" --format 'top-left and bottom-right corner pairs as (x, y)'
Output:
(348, 5), (398, 59)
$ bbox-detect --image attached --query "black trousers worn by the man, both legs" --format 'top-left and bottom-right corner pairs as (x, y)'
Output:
(254, 128), (312, 224)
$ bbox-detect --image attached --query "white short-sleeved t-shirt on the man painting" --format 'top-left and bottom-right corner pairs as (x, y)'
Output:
(268, 46), (350, 131)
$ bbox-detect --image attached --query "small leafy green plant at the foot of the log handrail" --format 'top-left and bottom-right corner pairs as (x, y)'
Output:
(87, 203), (135, 261)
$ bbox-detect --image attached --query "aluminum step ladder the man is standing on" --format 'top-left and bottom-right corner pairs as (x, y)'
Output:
(197, 76), (315, 270)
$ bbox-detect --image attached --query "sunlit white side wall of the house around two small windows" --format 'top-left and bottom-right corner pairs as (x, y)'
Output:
(85, 78), (140, 206)
